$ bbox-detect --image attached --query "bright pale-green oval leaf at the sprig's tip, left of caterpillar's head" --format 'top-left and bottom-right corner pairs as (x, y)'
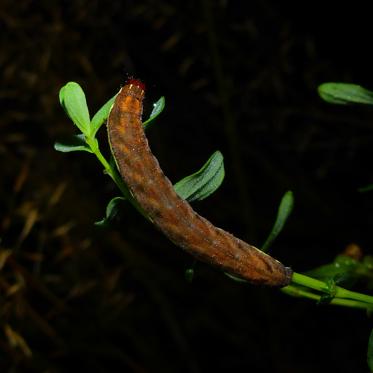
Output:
(59, 82), (90, 136)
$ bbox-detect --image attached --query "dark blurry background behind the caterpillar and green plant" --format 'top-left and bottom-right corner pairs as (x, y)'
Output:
(0, 0), (373, 373)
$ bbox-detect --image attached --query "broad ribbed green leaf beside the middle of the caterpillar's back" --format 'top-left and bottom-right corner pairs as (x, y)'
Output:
(174, 151), (225, 202)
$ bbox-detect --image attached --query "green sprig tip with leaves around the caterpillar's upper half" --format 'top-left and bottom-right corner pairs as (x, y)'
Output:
(54, 82), (224, 226)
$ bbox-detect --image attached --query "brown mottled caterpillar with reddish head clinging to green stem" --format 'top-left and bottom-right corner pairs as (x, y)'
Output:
(107, 79), (292, 286)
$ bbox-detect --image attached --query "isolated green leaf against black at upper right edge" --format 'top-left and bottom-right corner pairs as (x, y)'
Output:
(318, 83), (373, 105)
